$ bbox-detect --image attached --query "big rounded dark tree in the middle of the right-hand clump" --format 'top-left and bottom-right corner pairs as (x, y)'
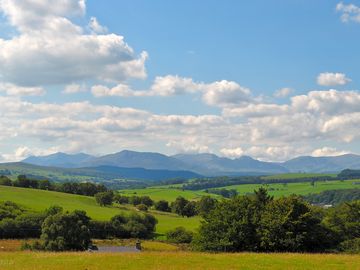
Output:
(258, 195), (333, 252)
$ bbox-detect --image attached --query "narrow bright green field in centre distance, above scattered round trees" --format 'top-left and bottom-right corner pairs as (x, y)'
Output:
(119, 185), (221, 202)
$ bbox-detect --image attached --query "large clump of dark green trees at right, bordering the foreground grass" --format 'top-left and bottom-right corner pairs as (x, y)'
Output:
(193, 188), (360, 252)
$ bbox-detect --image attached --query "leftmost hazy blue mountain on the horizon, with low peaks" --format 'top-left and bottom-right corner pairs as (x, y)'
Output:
(22, 152), (94, 168)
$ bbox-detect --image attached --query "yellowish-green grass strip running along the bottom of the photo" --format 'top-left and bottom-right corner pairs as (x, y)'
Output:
(0, 252), (360, 270)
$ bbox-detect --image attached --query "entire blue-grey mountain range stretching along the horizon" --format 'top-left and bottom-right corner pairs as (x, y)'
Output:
(22, 150), (360, 176)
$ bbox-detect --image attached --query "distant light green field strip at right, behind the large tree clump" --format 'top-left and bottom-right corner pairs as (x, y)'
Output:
(225, 180), (360, 197)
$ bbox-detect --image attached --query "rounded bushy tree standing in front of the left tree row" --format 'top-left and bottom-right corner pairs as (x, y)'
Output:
(41, 210), (91, 251)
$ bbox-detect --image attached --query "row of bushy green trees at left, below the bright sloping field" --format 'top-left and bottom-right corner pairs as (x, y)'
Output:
(0, 201), (157, 251)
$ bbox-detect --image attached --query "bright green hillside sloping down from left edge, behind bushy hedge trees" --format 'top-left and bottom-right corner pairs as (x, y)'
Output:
(0, 186), (200, 234)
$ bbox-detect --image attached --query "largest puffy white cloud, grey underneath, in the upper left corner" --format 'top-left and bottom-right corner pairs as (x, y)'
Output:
(0, 0), (147, 86)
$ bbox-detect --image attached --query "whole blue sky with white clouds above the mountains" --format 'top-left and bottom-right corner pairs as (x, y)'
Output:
(0, 0), (360, 162)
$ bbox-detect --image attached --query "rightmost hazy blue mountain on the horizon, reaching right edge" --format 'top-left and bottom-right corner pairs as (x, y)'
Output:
(281, 154), (360, 173)
